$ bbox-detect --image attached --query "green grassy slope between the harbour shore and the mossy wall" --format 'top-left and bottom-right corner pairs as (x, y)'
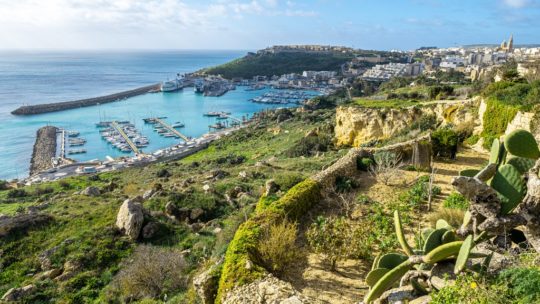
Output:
(0, 110), (346, 303)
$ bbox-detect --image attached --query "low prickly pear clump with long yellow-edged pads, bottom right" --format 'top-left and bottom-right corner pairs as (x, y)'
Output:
(364, 211), (488, 303)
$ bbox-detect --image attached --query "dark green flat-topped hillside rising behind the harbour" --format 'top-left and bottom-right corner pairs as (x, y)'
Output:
(202, 52), (354, 79)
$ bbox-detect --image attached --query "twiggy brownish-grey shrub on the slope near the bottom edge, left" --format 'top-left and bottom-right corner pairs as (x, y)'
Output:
(109, 245), (188, 300)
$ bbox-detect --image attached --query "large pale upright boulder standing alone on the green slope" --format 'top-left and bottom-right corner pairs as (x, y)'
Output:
(116, 199), (144, 240)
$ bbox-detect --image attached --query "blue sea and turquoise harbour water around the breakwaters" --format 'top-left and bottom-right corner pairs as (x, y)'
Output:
(0, 51), (312, 180)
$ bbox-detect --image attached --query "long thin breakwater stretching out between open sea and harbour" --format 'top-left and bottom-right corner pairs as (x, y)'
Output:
(11, 83), (161, 115)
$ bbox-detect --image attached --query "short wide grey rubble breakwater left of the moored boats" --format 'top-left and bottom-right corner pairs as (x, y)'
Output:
(30, 126), (58, 175)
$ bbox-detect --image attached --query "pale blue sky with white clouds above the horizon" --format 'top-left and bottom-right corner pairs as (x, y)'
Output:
(0, 0), (540, 50)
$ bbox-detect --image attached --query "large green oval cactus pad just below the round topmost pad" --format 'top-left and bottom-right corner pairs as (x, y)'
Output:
(491, 164), (527, 215)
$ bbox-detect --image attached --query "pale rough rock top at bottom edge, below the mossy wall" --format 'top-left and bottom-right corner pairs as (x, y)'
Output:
(222, 275), (320, 304)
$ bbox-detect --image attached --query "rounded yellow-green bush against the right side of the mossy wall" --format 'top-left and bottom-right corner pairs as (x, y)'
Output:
(258, 220), (300, 276)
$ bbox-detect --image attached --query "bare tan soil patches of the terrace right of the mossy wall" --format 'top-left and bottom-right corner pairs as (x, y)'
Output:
(286, 149), (487, 304)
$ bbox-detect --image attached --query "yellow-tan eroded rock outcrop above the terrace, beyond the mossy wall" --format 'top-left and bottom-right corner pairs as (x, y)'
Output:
(335, 99), (478, 147)
